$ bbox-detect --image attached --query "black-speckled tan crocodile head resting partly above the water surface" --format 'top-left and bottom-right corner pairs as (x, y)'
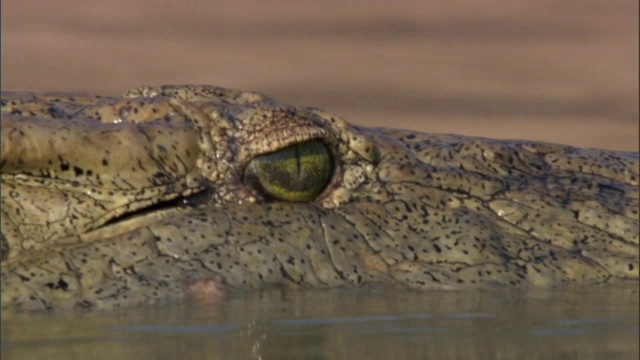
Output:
(0, 85), (640, 312)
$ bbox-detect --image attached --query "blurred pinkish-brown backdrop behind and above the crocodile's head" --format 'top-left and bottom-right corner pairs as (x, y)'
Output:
(1, 0), (639, 150)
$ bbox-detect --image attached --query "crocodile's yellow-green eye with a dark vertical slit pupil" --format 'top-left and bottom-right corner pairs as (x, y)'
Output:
(244, 140), (333, 201)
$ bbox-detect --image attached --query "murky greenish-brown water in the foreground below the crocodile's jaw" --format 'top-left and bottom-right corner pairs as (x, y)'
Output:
(2, 287), (640, 359)
